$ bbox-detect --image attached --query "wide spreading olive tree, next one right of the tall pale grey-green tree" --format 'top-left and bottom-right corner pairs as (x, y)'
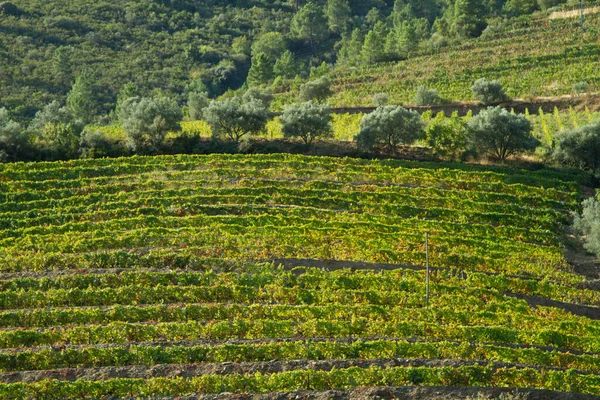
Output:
(204, 97), (270, 142)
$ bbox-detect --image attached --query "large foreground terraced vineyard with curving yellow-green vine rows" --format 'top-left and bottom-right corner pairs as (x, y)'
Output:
(0, 155), (600, 399)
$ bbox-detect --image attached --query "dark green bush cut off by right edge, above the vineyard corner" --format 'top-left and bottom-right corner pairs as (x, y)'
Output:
(554, 121), (600, 172)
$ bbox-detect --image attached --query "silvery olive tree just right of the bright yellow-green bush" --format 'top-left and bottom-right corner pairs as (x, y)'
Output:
(468, 107), (538, 161)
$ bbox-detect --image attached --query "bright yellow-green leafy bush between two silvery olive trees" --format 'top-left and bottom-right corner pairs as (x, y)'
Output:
(425, 112), (468, 158)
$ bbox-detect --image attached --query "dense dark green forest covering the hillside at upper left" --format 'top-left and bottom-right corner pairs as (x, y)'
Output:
(0, 0), (592, 123)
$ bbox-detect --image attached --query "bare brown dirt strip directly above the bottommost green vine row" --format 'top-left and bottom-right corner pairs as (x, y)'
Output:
(0, 358), (593, 383)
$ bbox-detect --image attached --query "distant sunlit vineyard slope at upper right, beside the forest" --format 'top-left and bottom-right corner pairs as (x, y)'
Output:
(276, 15), (600, 107)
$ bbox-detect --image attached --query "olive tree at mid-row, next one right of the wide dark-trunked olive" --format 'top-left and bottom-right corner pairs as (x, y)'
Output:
(280, 101), (333, 145)
